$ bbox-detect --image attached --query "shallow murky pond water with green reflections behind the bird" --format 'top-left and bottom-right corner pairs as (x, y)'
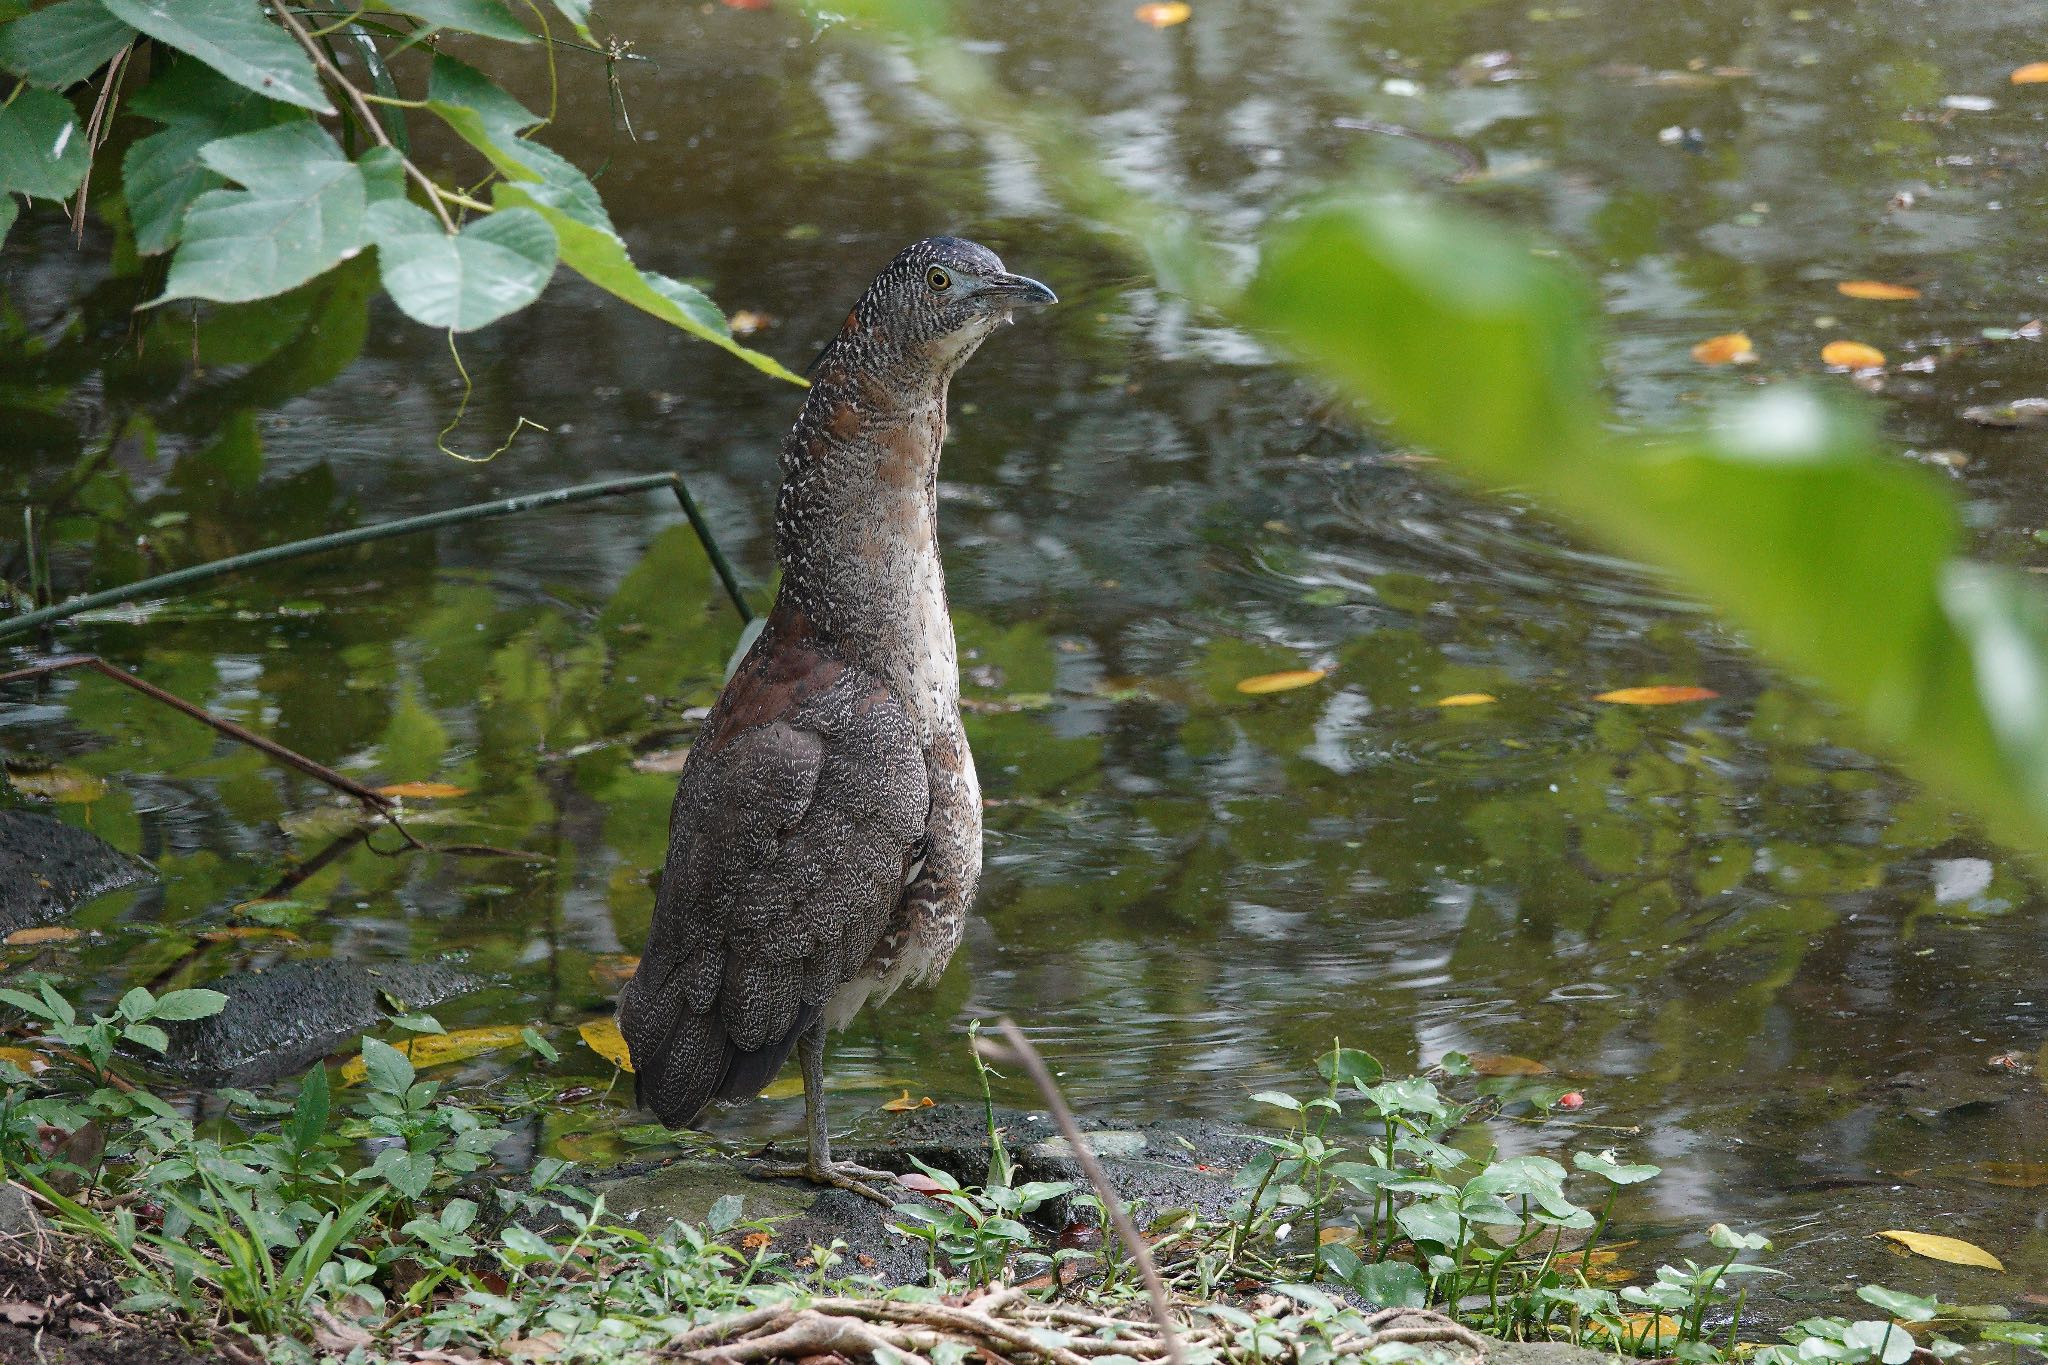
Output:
(0, 0), (2048, 1316)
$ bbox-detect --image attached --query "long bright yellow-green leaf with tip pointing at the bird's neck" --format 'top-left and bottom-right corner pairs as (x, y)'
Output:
(428, 100), (805, 385)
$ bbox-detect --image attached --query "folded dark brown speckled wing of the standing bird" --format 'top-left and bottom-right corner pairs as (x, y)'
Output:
(618, 636), (930, 1126)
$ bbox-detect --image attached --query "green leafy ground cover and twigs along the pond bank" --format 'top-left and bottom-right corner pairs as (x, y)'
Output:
(0, 980), (2048, 1365)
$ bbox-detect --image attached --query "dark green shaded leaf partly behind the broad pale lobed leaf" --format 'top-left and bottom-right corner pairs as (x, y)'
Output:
(121, 57), (301, 256)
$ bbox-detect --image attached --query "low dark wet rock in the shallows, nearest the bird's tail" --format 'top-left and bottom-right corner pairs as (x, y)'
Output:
(166, 960), (483, 1085)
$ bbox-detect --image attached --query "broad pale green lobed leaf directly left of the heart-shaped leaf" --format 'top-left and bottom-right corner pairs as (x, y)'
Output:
(158, 121), (367, 303)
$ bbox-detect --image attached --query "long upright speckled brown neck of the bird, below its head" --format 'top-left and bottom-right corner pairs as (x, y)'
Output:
(776, 352), (961, 737)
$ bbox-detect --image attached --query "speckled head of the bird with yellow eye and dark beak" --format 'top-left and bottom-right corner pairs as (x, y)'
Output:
(846, 237), (1059, 375)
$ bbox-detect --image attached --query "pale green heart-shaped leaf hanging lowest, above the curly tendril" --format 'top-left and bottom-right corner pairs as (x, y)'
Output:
(367, 199), (555, 332)
